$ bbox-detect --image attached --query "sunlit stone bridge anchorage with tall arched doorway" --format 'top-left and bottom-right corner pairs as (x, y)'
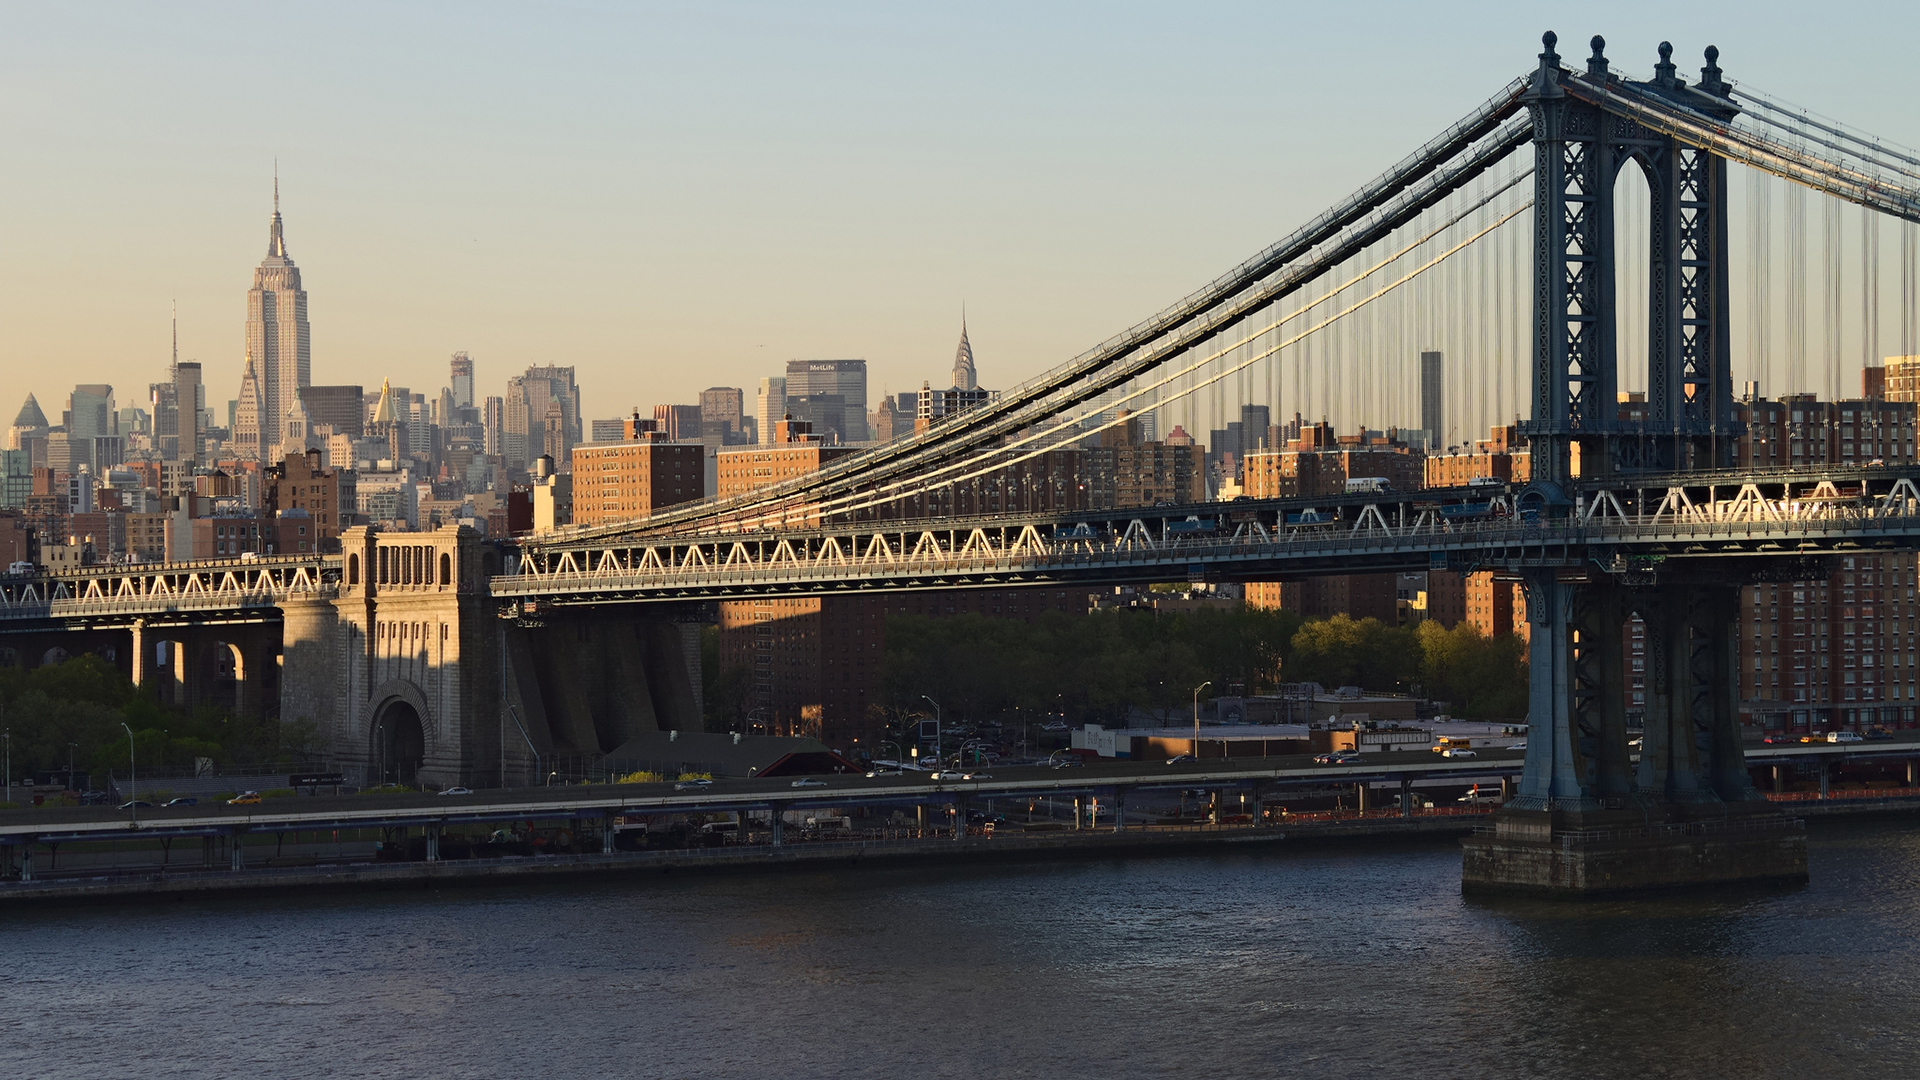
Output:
(280, 525), (701, 788)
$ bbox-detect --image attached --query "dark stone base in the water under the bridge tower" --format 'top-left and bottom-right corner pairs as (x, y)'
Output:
(1461, 803), (1807, 897)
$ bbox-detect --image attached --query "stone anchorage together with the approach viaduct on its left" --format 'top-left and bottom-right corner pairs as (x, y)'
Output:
(0, 527), (701, 788)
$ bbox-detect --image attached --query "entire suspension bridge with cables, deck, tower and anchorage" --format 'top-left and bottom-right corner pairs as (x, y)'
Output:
(0, 33), (1920, 882)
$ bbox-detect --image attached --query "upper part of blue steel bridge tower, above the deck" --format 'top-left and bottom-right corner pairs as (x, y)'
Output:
(1523, 33), (1740, 486)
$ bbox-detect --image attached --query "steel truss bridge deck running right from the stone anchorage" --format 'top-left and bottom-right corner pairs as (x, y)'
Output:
(490, 465), (1920, 605)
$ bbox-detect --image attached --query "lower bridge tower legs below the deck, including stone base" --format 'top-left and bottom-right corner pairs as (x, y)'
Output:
(1461, 569), (1807, 894)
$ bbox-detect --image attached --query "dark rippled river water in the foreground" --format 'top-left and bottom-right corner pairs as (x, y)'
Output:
(0, 821), (1920, 1080)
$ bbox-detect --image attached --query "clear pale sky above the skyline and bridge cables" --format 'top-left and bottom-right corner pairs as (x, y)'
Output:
(0, 0), (1920, 423)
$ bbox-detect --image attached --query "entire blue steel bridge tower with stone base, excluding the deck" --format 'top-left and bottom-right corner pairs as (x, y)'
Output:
(1463, 33), (1807, 894)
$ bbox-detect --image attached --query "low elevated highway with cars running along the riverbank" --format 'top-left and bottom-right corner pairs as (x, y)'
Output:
(0, 732), (1920, 847)
